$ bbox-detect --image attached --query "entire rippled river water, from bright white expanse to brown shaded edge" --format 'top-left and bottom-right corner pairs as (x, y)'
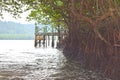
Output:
(0, 40), (110, 80)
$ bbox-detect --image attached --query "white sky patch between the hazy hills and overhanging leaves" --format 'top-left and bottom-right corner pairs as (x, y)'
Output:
(0, 12), (34, 24)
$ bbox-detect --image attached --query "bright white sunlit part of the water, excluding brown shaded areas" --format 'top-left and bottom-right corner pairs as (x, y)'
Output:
(0, 40), (67, 80)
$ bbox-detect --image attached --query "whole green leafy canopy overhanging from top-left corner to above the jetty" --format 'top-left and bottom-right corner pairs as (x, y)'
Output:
(0, 0), (66, 31)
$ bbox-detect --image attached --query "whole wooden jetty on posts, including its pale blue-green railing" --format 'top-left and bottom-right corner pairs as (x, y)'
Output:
(34, 26), (65, 47)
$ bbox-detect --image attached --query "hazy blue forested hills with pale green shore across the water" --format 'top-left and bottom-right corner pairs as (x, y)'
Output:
(0, 21), (35, 40)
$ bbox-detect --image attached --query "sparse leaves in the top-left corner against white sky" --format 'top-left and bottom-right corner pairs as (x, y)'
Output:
(0, 0), (24, 18)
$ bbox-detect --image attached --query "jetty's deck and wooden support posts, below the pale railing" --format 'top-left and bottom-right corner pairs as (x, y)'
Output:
(35, 33), (64, 47)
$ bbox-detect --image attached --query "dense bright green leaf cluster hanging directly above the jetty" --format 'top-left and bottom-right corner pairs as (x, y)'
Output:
(28, 1), (63, 25)
